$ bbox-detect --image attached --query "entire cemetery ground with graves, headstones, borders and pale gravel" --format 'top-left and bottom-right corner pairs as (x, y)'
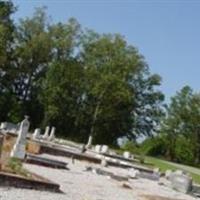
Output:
(0, 116), (200, 200)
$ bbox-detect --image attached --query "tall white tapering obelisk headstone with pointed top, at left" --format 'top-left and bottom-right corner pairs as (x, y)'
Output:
(10, 116), (30, 159)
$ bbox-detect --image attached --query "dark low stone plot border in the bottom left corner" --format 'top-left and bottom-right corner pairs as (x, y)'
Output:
(0, 172), (61, 192)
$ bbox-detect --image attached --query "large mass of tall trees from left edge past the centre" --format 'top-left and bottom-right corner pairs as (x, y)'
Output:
(0, 1), (164, 145)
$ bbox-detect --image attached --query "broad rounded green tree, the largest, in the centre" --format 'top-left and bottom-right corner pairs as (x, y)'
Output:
(80, 31), (163, 144)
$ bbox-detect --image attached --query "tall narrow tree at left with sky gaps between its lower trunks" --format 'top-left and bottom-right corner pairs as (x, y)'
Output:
(13, 8), (52, 125)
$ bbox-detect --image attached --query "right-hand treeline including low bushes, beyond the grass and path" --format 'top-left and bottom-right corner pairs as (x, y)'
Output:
(140, 86), (200, 166)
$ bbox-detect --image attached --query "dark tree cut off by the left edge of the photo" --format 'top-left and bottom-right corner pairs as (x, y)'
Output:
(0, 1), (16, 121)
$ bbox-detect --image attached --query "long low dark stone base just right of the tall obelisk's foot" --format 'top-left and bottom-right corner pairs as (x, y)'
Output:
(25, 154), (68, 169)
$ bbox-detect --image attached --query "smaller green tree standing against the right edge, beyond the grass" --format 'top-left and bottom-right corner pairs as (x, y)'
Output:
(161, 86), (200, 164)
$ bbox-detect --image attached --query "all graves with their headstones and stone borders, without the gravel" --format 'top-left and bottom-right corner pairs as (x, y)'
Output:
(0, 116), (200, 197)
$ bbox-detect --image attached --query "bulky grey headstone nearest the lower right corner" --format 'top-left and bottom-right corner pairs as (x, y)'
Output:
(170, 173), (192, 193)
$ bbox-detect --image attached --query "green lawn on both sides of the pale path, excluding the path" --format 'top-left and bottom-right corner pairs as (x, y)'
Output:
(145, 157), (200, 184)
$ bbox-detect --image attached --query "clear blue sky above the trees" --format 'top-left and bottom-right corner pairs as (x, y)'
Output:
(13, 0), (200, 102)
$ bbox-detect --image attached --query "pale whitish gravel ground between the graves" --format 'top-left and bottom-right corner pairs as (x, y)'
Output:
(0, 155), (198, 200)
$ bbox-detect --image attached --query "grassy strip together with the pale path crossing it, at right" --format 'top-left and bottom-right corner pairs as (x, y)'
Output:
(145, 157), (200, 184)
